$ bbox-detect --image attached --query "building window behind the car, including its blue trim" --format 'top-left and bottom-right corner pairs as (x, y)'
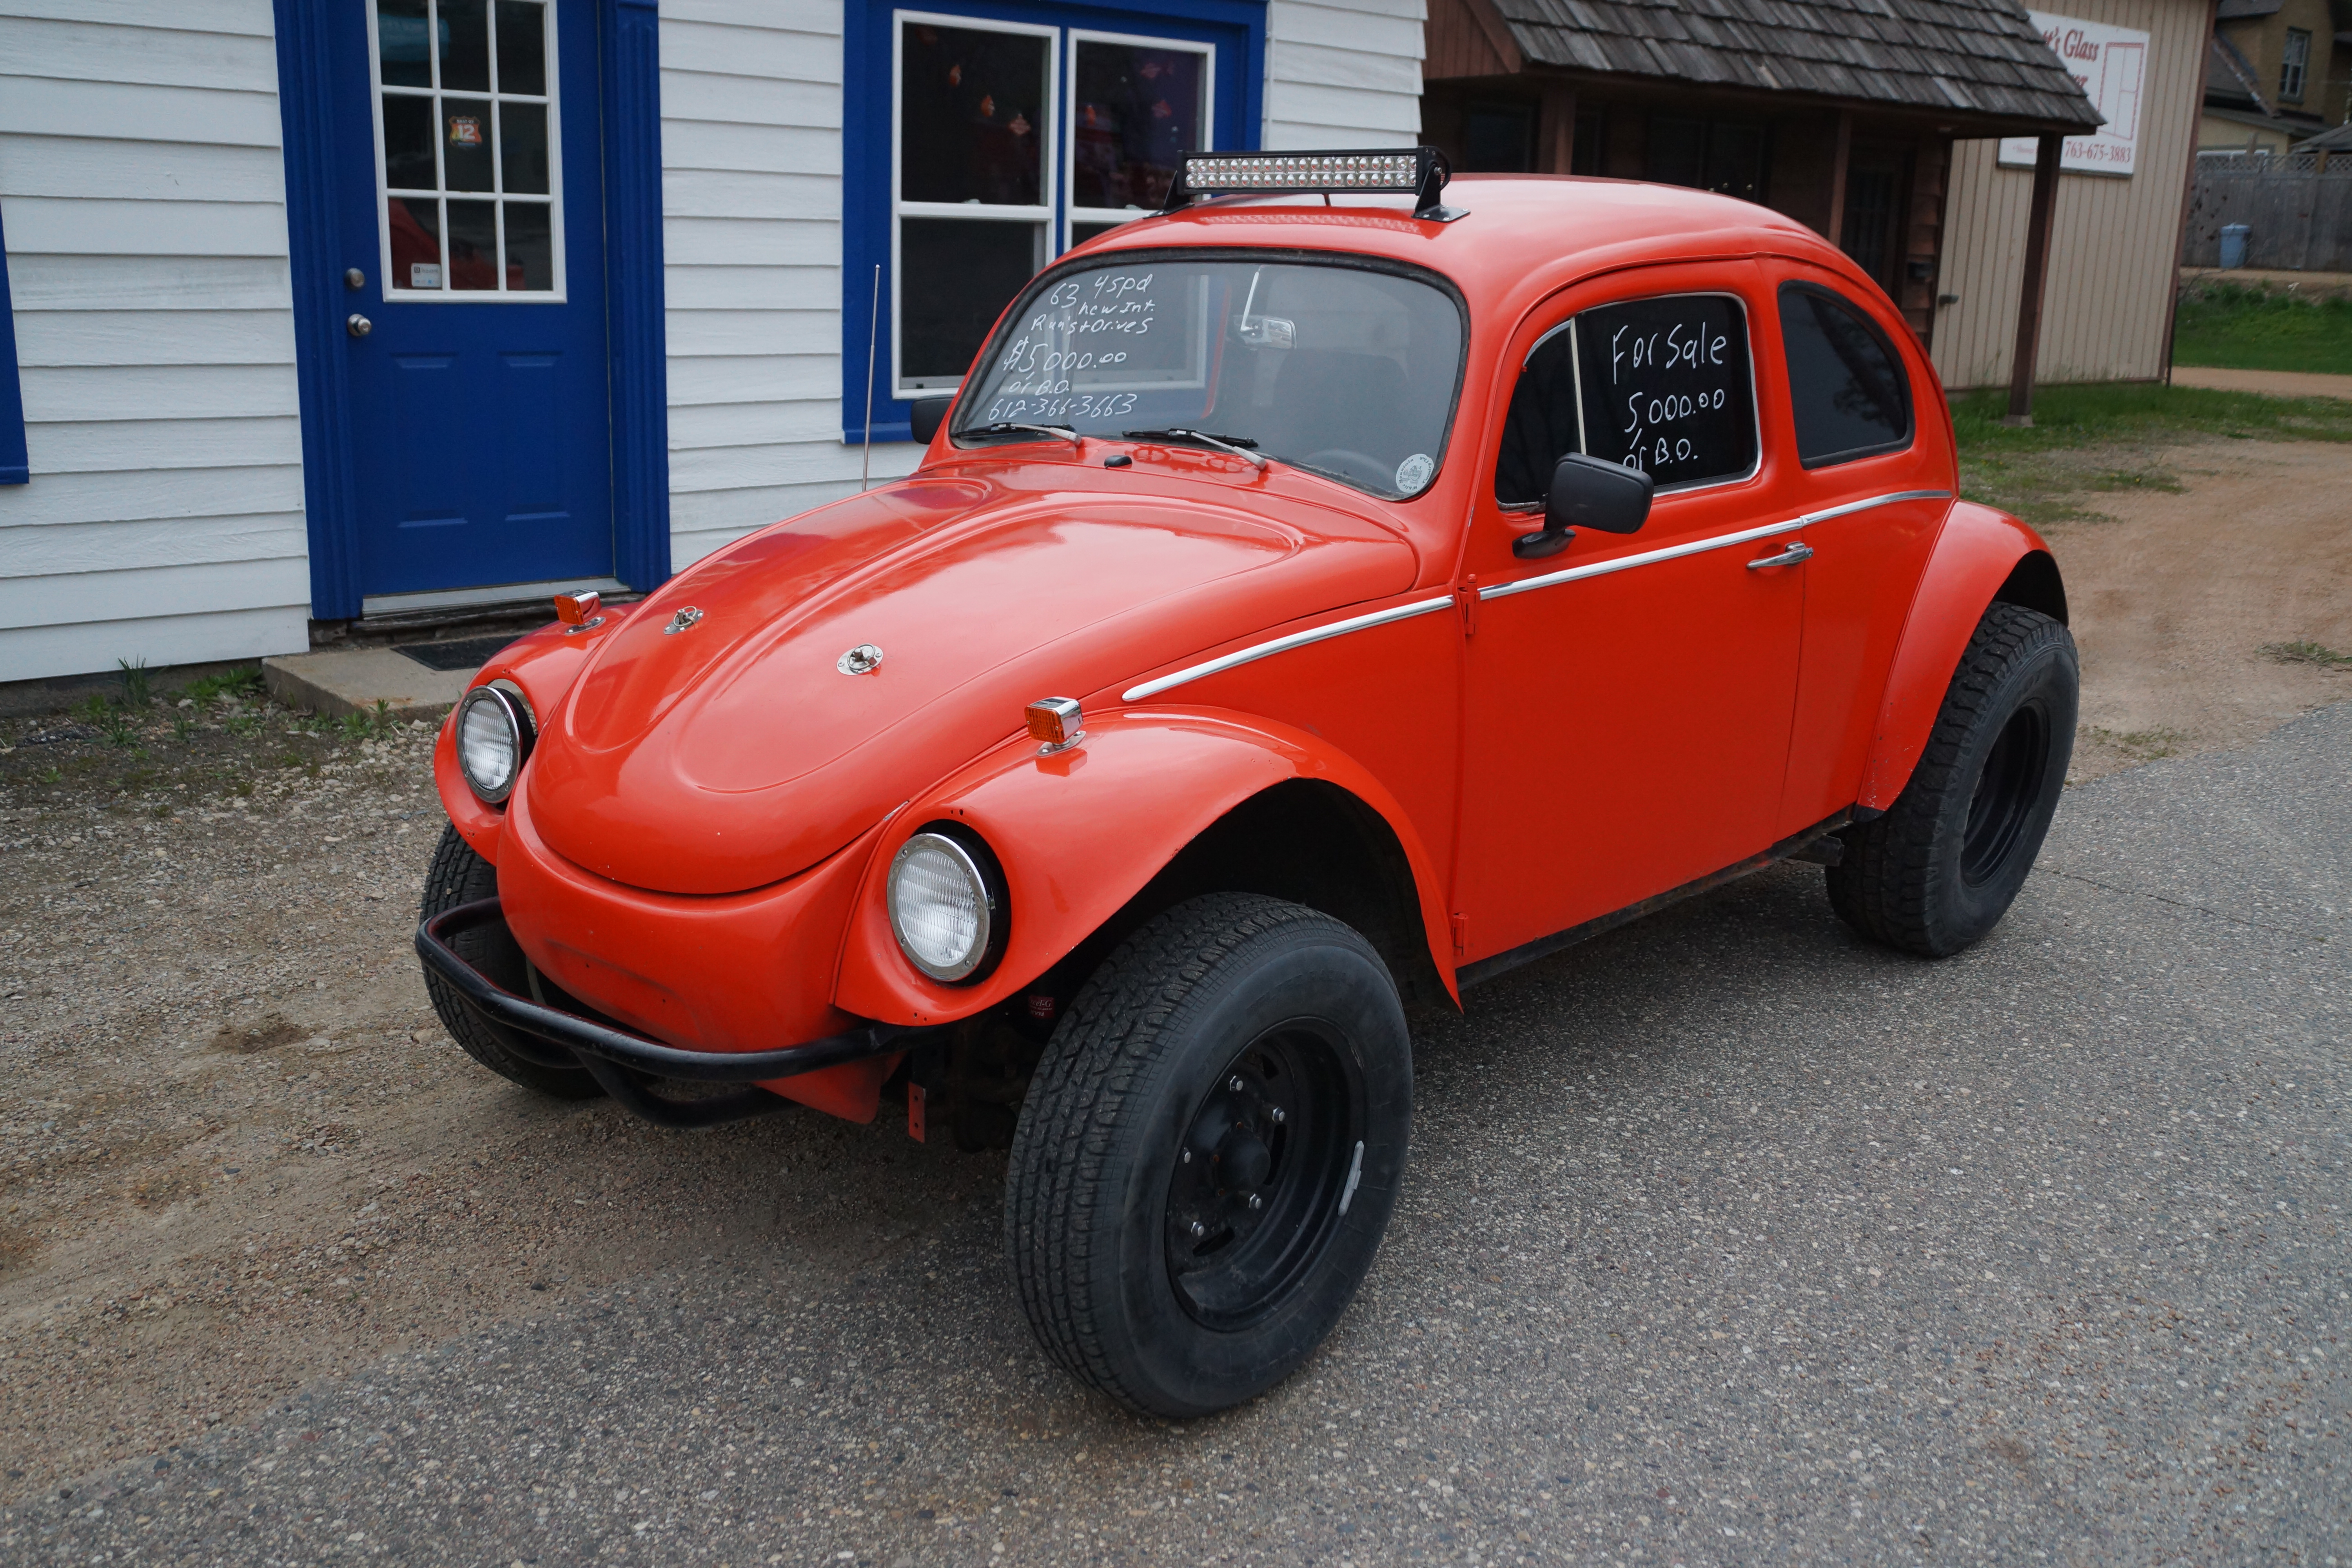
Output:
(837, 0), (1263, 439)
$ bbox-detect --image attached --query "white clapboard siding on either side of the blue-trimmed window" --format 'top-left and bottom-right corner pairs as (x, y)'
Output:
(654, 0), (1425, 566)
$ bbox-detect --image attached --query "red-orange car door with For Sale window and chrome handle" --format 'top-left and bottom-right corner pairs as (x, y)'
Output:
(1454, 263), (1804, 964)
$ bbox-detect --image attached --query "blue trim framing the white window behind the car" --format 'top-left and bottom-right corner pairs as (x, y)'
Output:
(842, 0), (1265, 446)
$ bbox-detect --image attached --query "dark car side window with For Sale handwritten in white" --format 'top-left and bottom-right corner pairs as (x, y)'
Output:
(1576, 294), (1757, 489)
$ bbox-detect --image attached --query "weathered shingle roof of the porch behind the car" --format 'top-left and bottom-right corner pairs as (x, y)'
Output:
(1489, 0), (2100, 129)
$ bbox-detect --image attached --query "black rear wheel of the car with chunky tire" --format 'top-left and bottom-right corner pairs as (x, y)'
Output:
(1830, 604), (2082, 959)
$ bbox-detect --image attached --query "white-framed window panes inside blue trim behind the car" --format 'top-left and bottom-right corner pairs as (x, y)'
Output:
(884, 12), (1216, 397)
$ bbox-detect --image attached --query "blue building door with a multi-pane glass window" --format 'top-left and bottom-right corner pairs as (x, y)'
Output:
(327, 0), (614, 611)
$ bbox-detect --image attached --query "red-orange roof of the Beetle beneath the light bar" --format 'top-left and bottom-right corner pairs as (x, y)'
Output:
(1075, 174), (1853, 306)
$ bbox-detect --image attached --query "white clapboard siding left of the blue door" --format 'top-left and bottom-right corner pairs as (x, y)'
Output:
(0, 0), (310, 679)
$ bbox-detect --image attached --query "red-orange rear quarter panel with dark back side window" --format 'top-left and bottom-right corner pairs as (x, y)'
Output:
(1766, 263), (1955, 837)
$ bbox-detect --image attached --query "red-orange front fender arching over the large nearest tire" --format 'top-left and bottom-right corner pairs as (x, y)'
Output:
(835, 708), (1458, 1023)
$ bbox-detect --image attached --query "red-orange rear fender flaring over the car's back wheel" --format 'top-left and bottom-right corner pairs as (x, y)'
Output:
(1858, 501), (2065, 811)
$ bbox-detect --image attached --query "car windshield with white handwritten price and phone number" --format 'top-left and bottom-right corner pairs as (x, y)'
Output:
(955, 256), (1463, 498)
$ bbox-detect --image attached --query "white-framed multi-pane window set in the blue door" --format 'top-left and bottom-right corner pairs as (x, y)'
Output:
(372, 0), (564, 301)
